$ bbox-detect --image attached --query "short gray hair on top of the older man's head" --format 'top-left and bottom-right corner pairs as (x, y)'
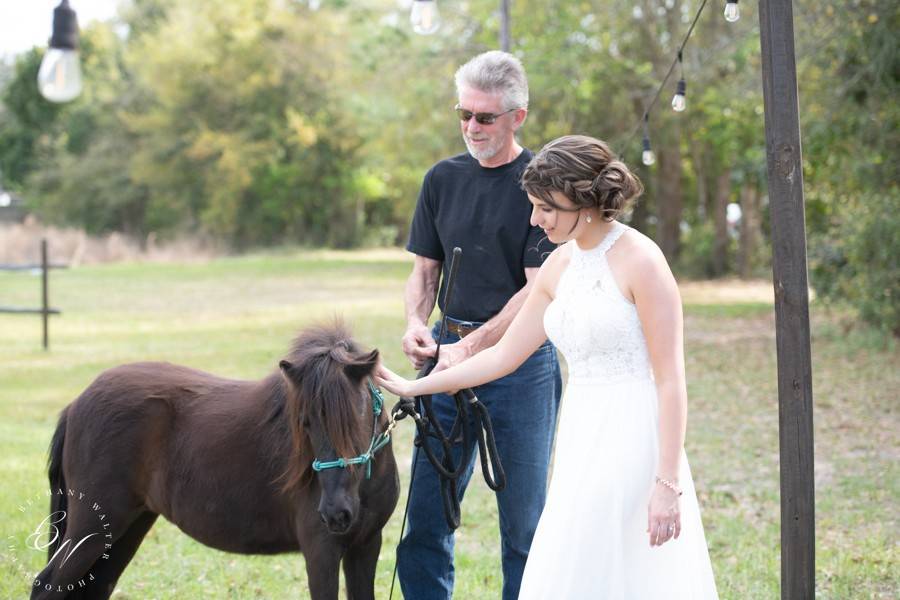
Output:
(455, 50), (528, 109)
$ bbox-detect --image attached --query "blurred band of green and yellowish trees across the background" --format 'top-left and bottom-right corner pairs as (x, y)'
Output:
(0, 0), (900, 328)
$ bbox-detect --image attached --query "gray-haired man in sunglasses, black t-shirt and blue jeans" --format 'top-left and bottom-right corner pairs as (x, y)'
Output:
(398, 51), (561, 600)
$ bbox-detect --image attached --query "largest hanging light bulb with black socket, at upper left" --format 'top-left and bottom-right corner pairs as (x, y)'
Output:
(38, 0), (81, 102)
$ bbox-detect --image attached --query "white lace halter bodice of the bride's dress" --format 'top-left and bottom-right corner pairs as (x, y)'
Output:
(544, 221), (652, 383)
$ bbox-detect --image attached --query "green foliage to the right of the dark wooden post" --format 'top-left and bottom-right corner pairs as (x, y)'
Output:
(804, 1), (900, 336)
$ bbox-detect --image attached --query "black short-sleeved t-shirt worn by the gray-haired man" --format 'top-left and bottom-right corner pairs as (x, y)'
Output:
(406, 150), (555, 321)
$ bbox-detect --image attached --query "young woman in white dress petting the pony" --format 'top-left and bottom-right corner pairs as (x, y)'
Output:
(376, 136), (717, 600)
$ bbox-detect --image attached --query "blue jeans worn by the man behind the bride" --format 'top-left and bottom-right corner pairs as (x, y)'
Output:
(397, 319), (562, 600)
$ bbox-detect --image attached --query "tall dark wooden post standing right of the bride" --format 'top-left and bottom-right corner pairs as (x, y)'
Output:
(759, 0), (816, 600)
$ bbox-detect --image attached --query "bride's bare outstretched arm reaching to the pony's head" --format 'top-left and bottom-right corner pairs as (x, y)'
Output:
(375, 257), (556, 397)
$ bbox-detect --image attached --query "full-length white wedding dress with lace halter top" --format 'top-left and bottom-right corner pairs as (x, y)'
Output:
(519, 222), (717, 600)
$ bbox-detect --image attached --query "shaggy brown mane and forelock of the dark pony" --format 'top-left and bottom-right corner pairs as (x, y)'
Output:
(280, 322), (378, 488)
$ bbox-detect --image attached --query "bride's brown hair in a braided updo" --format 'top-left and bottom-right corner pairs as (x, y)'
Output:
(522, 135), (644, 221)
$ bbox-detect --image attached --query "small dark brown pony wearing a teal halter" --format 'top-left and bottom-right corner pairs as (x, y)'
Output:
(31, 325), (399, 600)
